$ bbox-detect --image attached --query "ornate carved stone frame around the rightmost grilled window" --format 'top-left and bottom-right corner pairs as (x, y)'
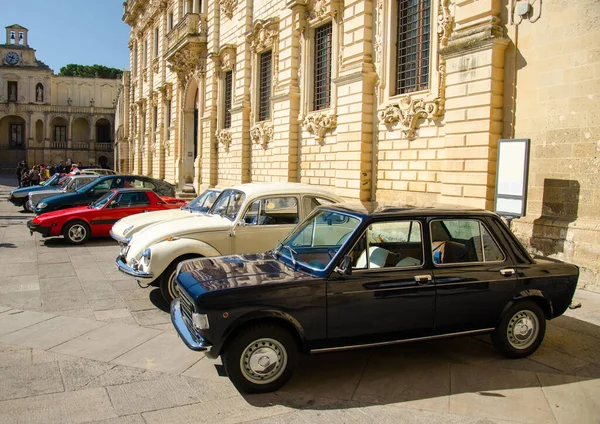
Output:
(374, 0), (453, 140)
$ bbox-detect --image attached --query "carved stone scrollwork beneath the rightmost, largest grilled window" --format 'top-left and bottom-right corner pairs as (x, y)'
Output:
(377, 96), (443, 140)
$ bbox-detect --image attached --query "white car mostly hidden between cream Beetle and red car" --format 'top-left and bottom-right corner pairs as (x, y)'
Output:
(110, 188), (221, 245)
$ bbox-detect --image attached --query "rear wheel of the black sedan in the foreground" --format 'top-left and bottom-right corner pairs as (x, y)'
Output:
(491, 300), (546, 358)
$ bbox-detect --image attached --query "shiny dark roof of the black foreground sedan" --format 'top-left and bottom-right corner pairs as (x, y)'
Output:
(319, 202), (497, 217)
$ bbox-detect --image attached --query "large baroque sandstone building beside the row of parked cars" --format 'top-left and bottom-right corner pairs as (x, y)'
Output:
(119, 0), (600, 286)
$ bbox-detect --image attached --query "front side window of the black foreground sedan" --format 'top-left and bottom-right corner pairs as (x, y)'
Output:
(350, 221), (423, 269)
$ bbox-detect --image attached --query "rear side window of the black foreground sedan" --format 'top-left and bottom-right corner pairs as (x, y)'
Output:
(431, 219), (504, 264)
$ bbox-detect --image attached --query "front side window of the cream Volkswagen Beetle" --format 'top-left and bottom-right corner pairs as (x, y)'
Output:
(244, 197), (298, 225)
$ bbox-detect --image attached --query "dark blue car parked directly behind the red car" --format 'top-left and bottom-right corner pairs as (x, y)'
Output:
(32, 175), (175, 215)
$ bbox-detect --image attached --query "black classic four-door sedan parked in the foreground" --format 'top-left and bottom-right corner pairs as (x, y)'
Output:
(171, 204), (579, 393)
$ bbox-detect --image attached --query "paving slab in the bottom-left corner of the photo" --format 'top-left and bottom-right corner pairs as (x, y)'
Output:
(0, 388), (117, 424)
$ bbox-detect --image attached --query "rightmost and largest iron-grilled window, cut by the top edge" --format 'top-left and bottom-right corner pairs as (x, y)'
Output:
(396, 0), (430, 94)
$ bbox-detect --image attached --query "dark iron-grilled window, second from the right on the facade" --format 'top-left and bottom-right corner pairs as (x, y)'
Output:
(314, 22), (332, 110)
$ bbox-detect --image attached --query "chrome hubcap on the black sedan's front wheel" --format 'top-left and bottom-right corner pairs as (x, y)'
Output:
(240, 339), (287, 384)
